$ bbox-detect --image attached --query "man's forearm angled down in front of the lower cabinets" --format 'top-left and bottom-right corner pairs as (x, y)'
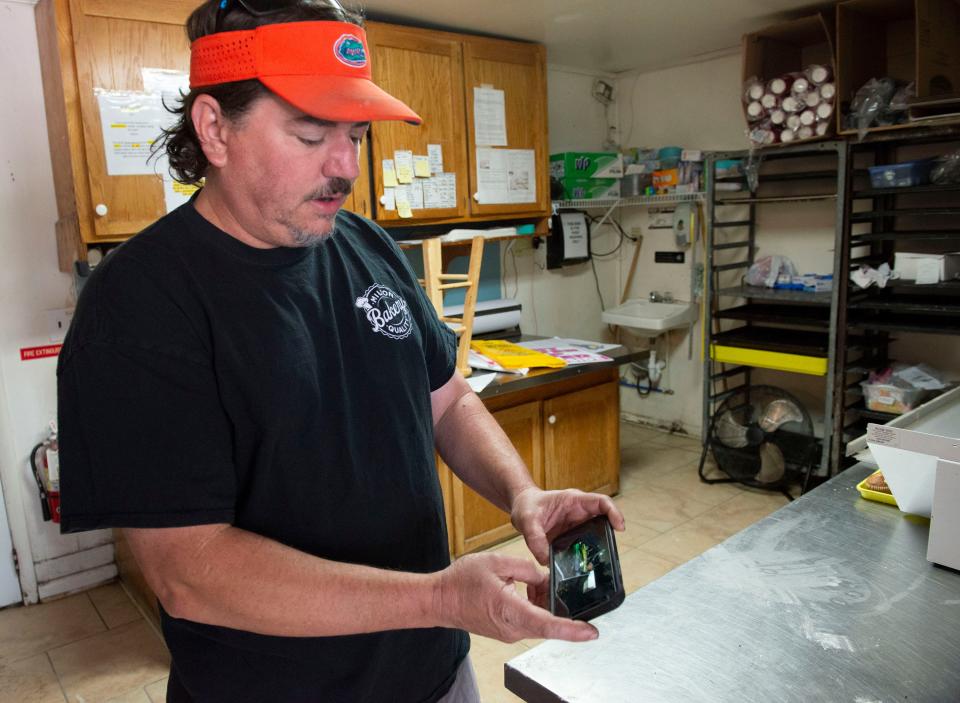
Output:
(434, 388), (535, 513)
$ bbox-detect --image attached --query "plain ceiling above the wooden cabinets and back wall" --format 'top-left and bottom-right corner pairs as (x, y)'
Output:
(360, 0), (822, 73)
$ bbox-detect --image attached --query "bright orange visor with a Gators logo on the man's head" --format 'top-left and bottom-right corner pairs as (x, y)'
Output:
(190, 22), (423, 124)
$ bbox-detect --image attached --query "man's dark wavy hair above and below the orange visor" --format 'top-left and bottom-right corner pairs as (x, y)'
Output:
(158, 0), (363, 184)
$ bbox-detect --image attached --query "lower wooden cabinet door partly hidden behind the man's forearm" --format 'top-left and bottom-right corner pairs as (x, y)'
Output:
(451, 401), (543, 556)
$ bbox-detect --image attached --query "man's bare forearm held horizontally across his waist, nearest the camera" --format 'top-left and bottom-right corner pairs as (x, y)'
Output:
(125, 526), (442, 637)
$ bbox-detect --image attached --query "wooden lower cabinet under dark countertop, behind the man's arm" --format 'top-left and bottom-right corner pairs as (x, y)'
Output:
(437, 369), (620, 556)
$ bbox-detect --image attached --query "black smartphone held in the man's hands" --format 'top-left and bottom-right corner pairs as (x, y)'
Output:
(550, 515), (625, 620)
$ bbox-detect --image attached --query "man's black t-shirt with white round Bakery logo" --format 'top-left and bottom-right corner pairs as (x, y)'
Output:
(57, 203), (469, 703)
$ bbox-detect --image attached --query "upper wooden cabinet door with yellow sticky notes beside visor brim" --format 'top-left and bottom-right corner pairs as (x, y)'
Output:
(367, 22), (468, 222)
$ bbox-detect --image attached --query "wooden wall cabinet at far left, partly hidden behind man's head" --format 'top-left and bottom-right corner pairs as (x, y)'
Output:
(36, 0), (373, 271)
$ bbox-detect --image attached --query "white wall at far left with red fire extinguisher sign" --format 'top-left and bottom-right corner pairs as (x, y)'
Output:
(0, 0), (116, 601)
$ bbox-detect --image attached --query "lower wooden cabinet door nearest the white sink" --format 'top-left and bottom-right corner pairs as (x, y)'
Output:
(543, 381), (620, 495)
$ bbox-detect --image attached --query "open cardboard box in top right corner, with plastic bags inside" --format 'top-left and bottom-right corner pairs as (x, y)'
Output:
(836, 0), (960, 134)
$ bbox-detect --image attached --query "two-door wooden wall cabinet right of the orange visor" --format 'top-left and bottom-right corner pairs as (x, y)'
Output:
(367, 22), (550, 227)
